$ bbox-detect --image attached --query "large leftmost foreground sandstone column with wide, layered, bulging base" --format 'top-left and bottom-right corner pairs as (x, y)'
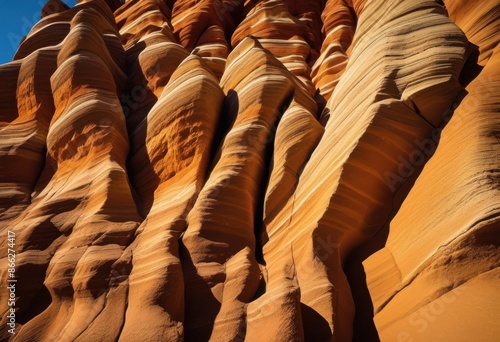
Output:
(0, 9), (139, 341)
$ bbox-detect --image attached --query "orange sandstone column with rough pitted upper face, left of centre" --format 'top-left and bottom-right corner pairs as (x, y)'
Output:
(120, 55), (224, 341)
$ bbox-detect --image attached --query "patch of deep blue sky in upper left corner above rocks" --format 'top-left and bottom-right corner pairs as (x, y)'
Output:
(0, 0), (76, 64)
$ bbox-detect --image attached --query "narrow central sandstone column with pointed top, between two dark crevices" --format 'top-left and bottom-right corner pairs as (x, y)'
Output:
(181, 38), (293, 341)
